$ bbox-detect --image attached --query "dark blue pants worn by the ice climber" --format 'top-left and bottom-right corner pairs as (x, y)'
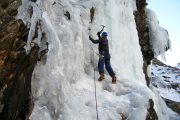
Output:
(98, 52), (115, 77)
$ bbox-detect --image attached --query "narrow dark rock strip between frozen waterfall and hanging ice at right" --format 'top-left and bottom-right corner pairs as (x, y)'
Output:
(134, 0), (154, 86)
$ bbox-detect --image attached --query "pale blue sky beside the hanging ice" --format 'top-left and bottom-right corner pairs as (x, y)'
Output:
(147, 0), (180, 66)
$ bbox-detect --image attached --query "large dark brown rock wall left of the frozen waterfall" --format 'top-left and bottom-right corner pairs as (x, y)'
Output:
(0, 0), (39, 120)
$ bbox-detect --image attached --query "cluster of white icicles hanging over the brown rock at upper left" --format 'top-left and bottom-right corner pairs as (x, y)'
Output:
(17, 0), (43, 54)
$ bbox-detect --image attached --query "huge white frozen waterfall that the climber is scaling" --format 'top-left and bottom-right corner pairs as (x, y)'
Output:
(16, 0), (179, 120)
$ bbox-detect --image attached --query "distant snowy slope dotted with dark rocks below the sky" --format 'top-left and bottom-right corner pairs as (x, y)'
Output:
(152, 60), (180, 103)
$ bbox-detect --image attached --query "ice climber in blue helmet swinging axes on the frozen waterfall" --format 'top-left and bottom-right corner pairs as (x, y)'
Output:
(89, 31), (116, 84)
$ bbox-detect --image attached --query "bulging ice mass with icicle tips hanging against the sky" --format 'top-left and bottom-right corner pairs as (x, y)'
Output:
(146, 9), (171, 61)
